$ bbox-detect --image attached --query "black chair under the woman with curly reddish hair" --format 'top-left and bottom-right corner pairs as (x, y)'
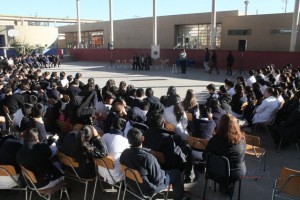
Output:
(203, 153), (242, 200)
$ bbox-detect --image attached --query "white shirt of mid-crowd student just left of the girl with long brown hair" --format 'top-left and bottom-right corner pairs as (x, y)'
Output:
(163, 106), (188, 140)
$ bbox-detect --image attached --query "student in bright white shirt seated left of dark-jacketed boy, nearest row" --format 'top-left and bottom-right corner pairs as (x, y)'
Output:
(98, 117), (129, 184)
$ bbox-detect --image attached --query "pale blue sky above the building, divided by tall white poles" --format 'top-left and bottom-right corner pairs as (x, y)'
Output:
(0, 0), (295, 21)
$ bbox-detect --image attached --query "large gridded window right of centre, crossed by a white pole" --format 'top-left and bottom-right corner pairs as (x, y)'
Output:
(175, 24), (222, 49)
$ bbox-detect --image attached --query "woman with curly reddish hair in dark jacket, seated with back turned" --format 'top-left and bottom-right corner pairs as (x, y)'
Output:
(203, 114), (246, 192)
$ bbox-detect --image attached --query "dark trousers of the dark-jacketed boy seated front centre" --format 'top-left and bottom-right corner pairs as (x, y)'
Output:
(165, 169), (185, 200)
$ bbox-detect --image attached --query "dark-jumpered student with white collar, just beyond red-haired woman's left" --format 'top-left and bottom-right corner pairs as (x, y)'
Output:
(192, 105), (216, 139)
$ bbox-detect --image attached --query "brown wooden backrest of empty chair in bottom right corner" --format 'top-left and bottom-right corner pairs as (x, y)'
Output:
(277, 167), (300, 197)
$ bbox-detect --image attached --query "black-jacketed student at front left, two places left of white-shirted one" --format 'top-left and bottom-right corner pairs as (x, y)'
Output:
(17, 128), (64, 189)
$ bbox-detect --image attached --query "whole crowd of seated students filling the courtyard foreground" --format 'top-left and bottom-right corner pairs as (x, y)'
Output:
(0, 57), (300, 199)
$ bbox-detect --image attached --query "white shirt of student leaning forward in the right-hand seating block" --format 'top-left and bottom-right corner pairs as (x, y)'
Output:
(252, 96), (279, 124)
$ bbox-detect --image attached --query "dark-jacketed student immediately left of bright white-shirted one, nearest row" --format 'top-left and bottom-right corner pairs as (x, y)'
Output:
(60, 125), (108, 178)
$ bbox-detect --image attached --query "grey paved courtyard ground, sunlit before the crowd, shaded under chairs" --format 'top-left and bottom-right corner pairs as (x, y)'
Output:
(0, 62), (300, 200)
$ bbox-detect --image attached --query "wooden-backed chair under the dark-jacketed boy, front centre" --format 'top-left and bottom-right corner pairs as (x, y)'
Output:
(121, 165), (170, 200)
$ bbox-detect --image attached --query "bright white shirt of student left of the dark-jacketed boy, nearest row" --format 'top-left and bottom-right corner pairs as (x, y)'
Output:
(98, 133), (129, 184)
